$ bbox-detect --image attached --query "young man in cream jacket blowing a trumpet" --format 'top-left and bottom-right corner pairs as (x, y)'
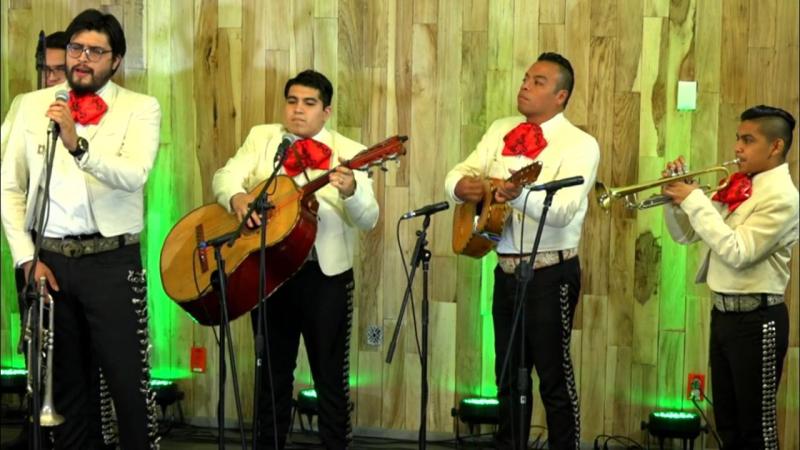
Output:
(662, 105), (798, 449)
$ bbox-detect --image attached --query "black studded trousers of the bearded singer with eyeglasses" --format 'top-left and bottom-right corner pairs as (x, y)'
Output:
(41, 245), (158, 450)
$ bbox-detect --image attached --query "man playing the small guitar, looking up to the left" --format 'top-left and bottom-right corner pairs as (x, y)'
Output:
(445, 53), (600, 449)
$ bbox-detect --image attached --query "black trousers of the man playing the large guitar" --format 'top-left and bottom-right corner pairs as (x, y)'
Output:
(251, 261), (353, 449)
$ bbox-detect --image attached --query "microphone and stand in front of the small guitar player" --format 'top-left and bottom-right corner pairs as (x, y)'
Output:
(499, 188), (558, 450)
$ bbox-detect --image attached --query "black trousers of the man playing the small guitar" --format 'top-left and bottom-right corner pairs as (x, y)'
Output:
(492, 258), (581, 449)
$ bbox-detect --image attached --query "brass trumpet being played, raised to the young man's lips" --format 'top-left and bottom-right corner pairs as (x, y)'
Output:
(594, 158), (739, 211)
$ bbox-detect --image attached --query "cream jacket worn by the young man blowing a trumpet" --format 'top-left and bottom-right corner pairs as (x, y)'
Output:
(664, 163), (799, 294)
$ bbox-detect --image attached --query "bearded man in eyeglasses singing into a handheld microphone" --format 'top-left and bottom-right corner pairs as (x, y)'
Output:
(0, 10), (161, 449)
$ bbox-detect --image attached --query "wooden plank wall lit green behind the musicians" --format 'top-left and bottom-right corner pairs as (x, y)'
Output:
(0, 0), (800, 448)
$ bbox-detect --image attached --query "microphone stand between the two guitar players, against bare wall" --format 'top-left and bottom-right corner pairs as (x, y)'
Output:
(386, 211), (435, 450)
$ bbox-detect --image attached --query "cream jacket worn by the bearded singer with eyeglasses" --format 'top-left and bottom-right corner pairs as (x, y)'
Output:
(0, 82), (161, 265)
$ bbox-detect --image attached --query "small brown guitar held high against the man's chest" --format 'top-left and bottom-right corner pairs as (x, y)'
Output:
(453, 161), (542, 258)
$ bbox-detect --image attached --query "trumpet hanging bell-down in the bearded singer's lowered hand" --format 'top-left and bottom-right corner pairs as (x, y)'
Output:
(25, 277), (64, 427)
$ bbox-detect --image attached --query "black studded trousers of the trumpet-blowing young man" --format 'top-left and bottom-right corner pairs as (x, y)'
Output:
(709, 303), (789, 449)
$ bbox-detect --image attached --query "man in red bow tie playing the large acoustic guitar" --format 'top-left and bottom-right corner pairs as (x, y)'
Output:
(213, 70), (379, 449)
